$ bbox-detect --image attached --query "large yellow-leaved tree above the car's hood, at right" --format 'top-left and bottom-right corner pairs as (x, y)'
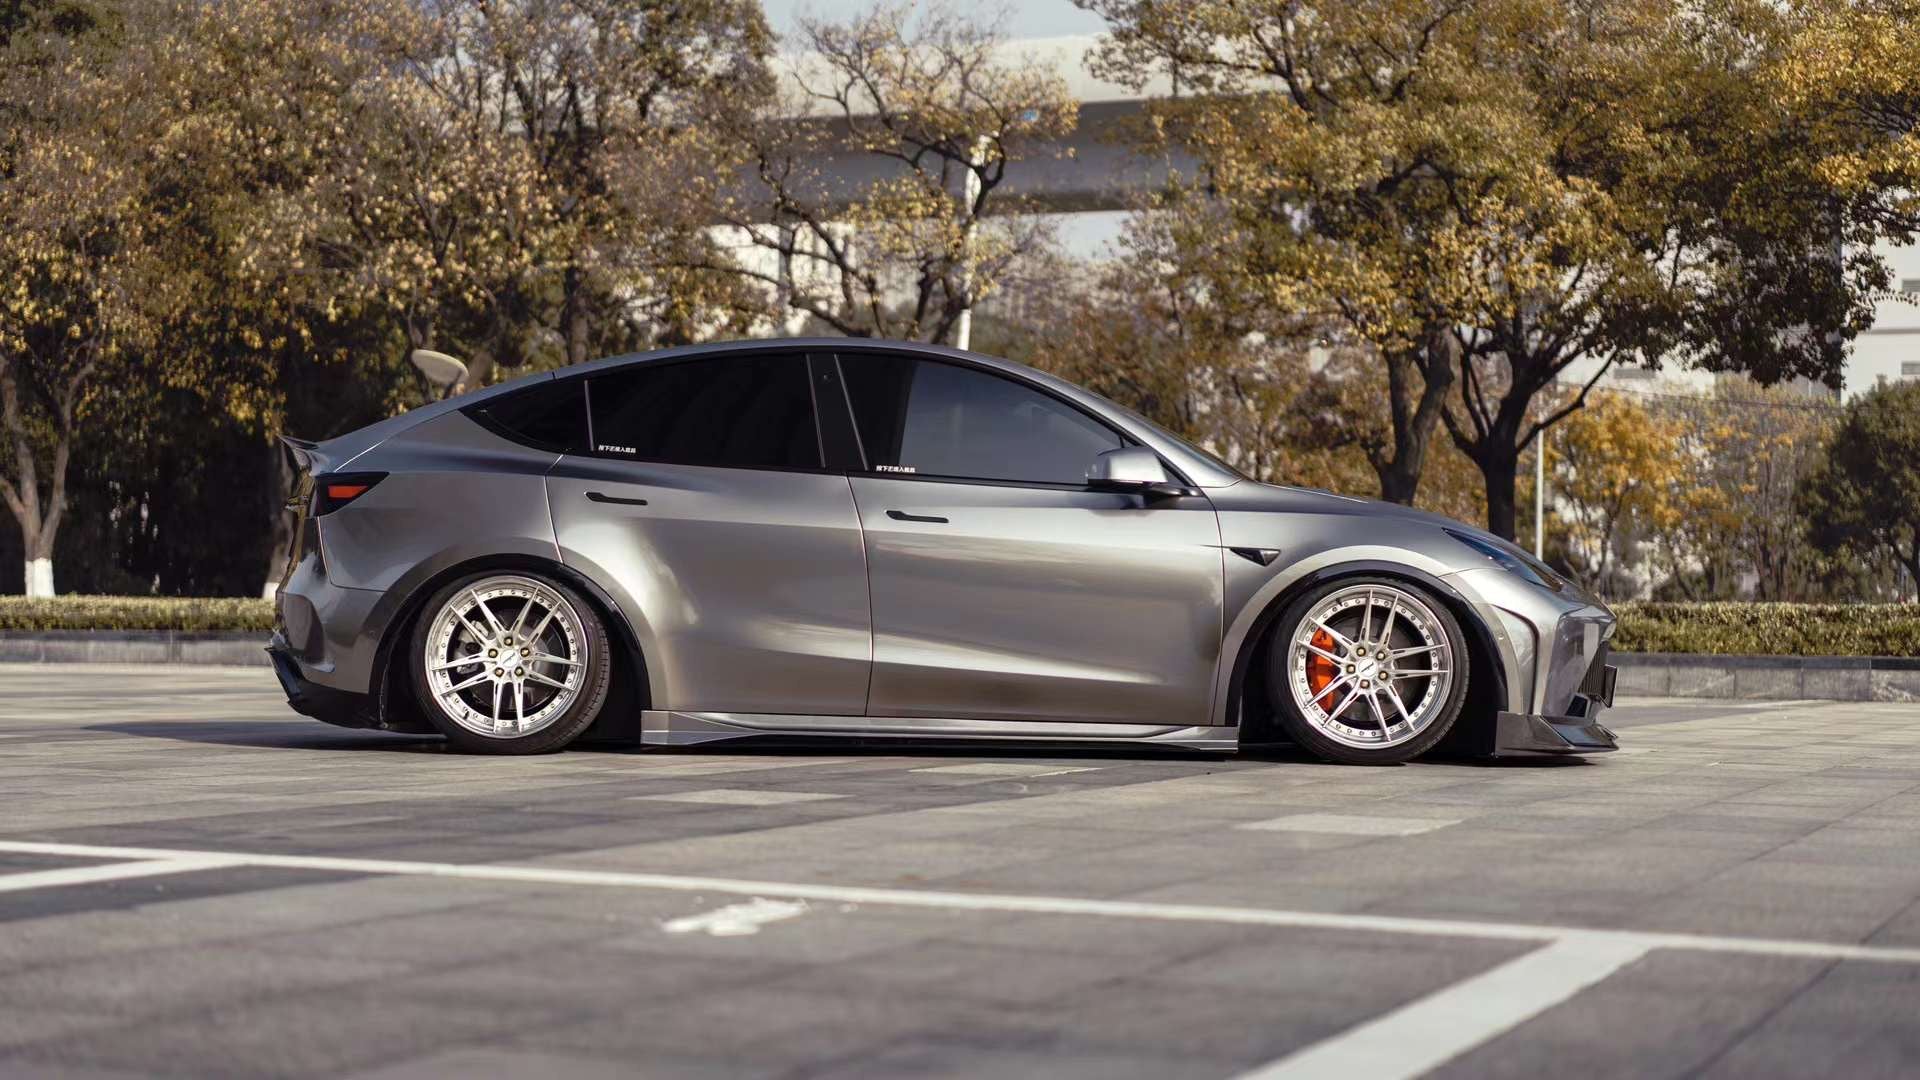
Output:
(1085, 0), (1920, 536)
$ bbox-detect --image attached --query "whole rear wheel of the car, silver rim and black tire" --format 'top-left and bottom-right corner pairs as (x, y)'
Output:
(413, 573), (612, 753)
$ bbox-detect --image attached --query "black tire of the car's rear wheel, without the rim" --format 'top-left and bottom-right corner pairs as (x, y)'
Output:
(407, 571), (612, 753)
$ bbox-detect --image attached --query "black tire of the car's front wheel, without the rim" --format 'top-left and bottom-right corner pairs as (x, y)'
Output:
(1263, 575), (1473, 765)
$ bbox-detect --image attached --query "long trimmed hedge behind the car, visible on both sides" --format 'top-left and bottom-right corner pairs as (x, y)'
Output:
(0, 596), (1920, 657)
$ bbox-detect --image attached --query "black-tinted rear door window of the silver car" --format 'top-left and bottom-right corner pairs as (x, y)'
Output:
(588, 354), (820, 469)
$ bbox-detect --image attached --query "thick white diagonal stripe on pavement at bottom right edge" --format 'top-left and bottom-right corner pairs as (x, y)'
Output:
(1240, 934), (1649, 1080)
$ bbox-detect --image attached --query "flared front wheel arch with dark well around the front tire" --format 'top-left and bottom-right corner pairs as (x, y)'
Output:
(1213, 546), (1530, 742)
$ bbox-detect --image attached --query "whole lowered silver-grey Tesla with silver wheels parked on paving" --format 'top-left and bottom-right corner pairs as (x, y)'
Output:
(271, 338), (1615, 763)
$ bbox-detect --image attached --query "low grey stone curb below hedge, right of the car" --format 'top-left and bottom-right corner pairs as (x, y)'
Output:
(1613, 653), (1920, 701)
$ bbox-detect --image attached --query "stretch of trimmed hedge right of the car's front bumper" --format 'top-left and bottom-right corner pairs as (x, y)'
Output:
(1613, 601), (1920, 657)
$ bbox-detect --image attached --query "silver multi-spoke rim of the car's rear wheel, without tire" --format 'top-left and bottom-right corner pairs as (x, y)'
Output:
(422, 575), (586, 738)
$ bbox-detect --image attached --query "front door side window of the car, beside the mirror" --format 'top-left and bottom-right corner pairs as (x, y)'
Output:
(841, 354), (1121, 484)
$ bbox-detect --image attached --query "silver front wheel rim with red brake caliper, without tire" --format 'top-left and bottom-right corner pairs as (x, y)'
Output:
(1286, 582), (1455, 749)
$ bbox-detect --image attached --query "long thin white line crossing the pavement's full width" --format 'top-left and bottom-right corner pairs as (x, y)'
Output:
(0, 840), (1920, 965)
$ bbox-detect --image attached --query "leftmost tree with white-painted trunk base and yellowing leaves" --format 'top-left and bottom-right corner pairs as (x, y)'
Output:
(0, 0), (188, 596)
